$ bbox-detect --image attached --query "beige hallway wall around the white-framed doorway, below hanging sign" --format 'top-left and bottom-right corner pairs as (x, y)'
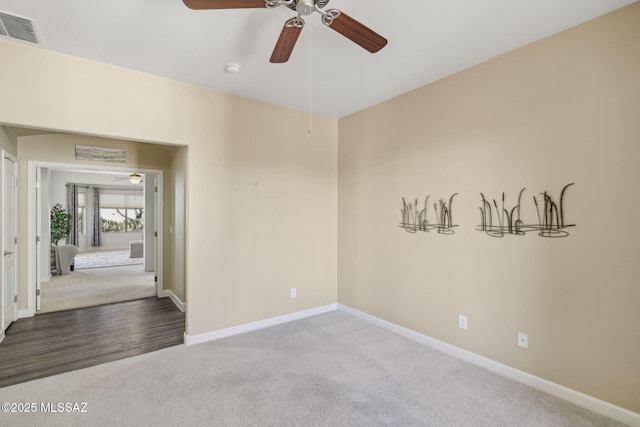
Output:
(18, 134), (182, 300)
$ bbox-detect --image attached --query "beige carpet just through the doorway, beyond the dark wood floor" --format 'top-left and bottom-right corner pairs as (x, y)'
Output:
(39, 265), (156, 313)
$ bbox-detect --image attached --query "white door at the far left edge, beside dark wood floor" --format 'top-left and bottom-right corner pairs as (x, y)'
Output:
(2, 151), (18, 331)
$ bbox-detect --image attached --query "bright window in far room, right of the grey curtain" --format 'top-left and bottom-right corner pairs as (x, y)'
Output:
(100, 189), (144, 233)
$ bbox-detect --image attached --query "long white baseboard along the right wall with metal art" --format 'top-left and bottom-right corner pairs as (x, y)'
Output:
(338, 304), (640, 427)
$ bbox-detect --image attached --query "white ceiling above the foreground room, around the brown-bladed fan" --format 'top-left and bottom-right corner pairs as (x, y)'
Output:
(0, 0), (635, 117)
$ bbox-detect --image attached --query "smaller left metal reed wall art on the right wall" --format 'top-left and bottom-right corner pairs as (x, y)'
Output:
(400, 193), (458, 234)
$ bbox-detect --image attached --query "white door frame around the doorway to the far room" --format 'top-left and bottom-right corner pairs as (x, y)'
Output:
(26, 160), (164, 316)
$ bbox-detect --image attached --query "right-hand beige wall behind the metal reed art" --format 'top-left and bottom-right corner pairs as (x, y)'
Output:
(338, 4), (640, 412)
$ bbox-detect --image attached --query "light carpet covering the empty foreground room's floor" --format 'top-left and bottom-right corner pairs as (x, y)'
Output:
(0, 311), (622, 427)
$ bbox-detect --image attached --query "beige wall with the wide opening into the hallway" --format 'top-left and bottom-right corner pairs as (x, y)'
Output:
(0, 40), (338, 334)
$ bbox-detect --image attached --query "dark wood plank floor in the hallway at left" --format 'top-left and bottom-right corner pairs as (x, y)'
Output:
(0, 297), (185, 387)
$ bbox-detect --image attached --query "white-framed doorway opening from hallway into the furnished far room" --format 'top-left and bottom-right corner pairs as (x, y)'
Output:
(28, 162), (163, 314)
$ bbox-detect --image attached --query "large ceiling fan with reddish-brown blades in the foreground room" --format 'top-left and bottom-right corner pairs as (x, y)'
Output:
(183, 0), (387, 63)
